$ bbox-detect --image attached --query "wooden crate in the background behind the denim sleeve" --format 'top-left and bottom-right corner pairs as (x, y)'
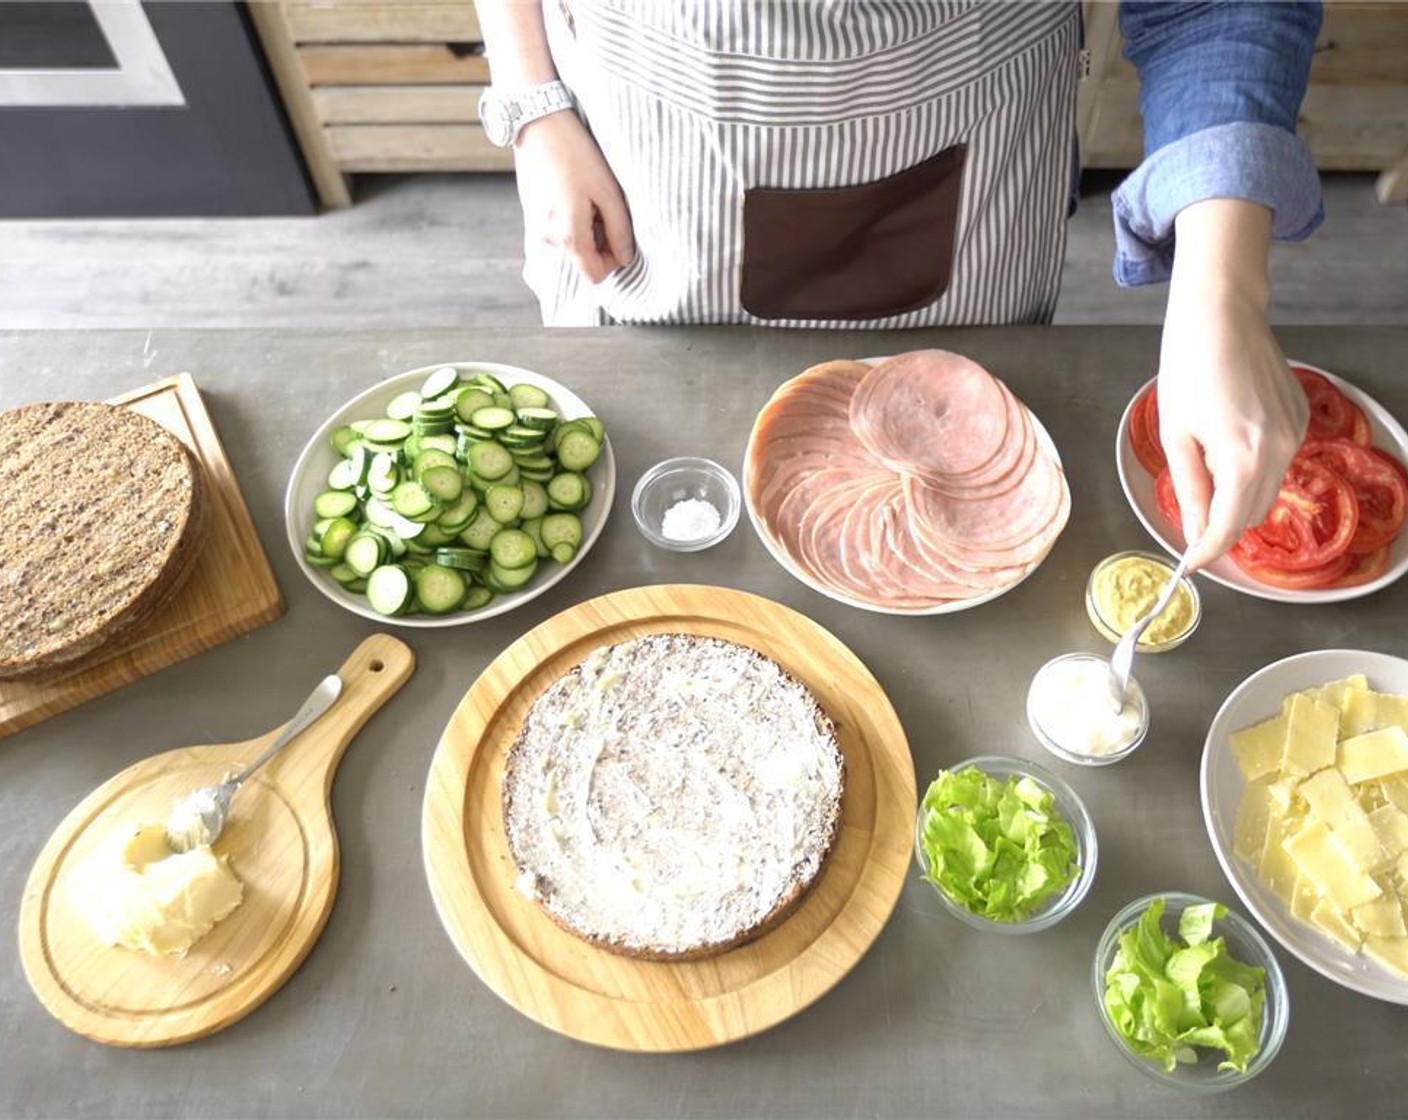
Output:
(1077, 3), (1408, 203)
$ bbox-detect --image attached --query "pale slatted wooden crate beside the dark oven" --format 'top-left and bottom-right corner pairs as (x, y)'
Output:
(249, 0), (513, 207)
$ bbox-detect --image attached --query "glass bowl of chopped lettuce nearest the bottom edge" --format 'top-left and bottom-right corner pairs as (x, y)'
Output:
(1091, 890), (1291, 1092)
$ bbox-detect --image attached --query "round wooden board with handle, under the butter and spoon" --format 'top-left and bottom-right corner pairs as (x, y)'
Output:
(20, 634), (415, 1047)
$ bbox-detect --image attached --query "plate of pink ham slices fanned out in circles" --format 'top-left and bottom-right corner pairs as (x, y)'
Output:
(745, 349), (1070, 611)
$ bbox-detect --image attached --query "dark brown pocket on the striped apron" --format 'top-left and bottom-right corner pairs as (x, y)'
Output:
(739, 144), (966, 320)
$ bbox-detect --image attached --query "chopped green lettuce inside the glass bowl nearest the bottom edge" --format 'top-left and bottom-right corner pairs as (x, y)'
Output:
(1104, 899), (1266, 1074)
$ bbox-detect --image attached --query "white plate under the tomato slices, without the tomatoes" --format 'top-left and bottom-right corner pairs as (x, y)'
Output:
(1115, 358), (1408, 603)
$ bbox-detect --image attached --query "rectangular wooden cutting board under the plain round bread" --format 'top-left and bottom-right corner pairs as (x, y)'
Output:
(0, 373), (283, 738)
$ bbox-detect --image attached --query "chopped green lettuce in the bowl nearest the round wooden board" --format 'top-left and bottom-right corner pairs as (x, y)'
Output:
(919, 768), (1080, 921)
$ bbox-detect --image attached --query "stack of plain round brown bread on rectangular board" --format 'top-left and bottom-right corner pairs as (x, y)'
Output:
(0, 402), (204, 679)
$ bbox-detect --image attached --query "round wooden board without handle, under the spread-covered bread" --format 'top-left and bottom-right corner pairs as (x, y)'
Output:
(421, 585), (915, 1051)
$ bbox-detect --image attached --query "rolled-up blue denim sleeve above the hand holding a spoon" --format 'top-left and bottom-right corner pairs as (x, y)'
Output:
(1112, 0), (1325, 287)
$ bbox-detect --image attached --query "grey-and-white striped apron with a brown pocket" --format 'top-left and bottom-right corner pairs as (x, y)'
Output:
(524, 0), (1080, 327)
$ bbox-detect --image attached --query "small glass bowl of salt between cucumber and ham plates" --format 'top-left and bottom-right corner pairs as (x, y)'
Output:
(631, 456), (741, 552)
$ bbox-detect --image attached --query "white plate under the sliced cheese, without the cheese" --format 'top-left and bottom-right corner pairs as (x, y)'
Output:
(1200, 649), (1408, 1004)
